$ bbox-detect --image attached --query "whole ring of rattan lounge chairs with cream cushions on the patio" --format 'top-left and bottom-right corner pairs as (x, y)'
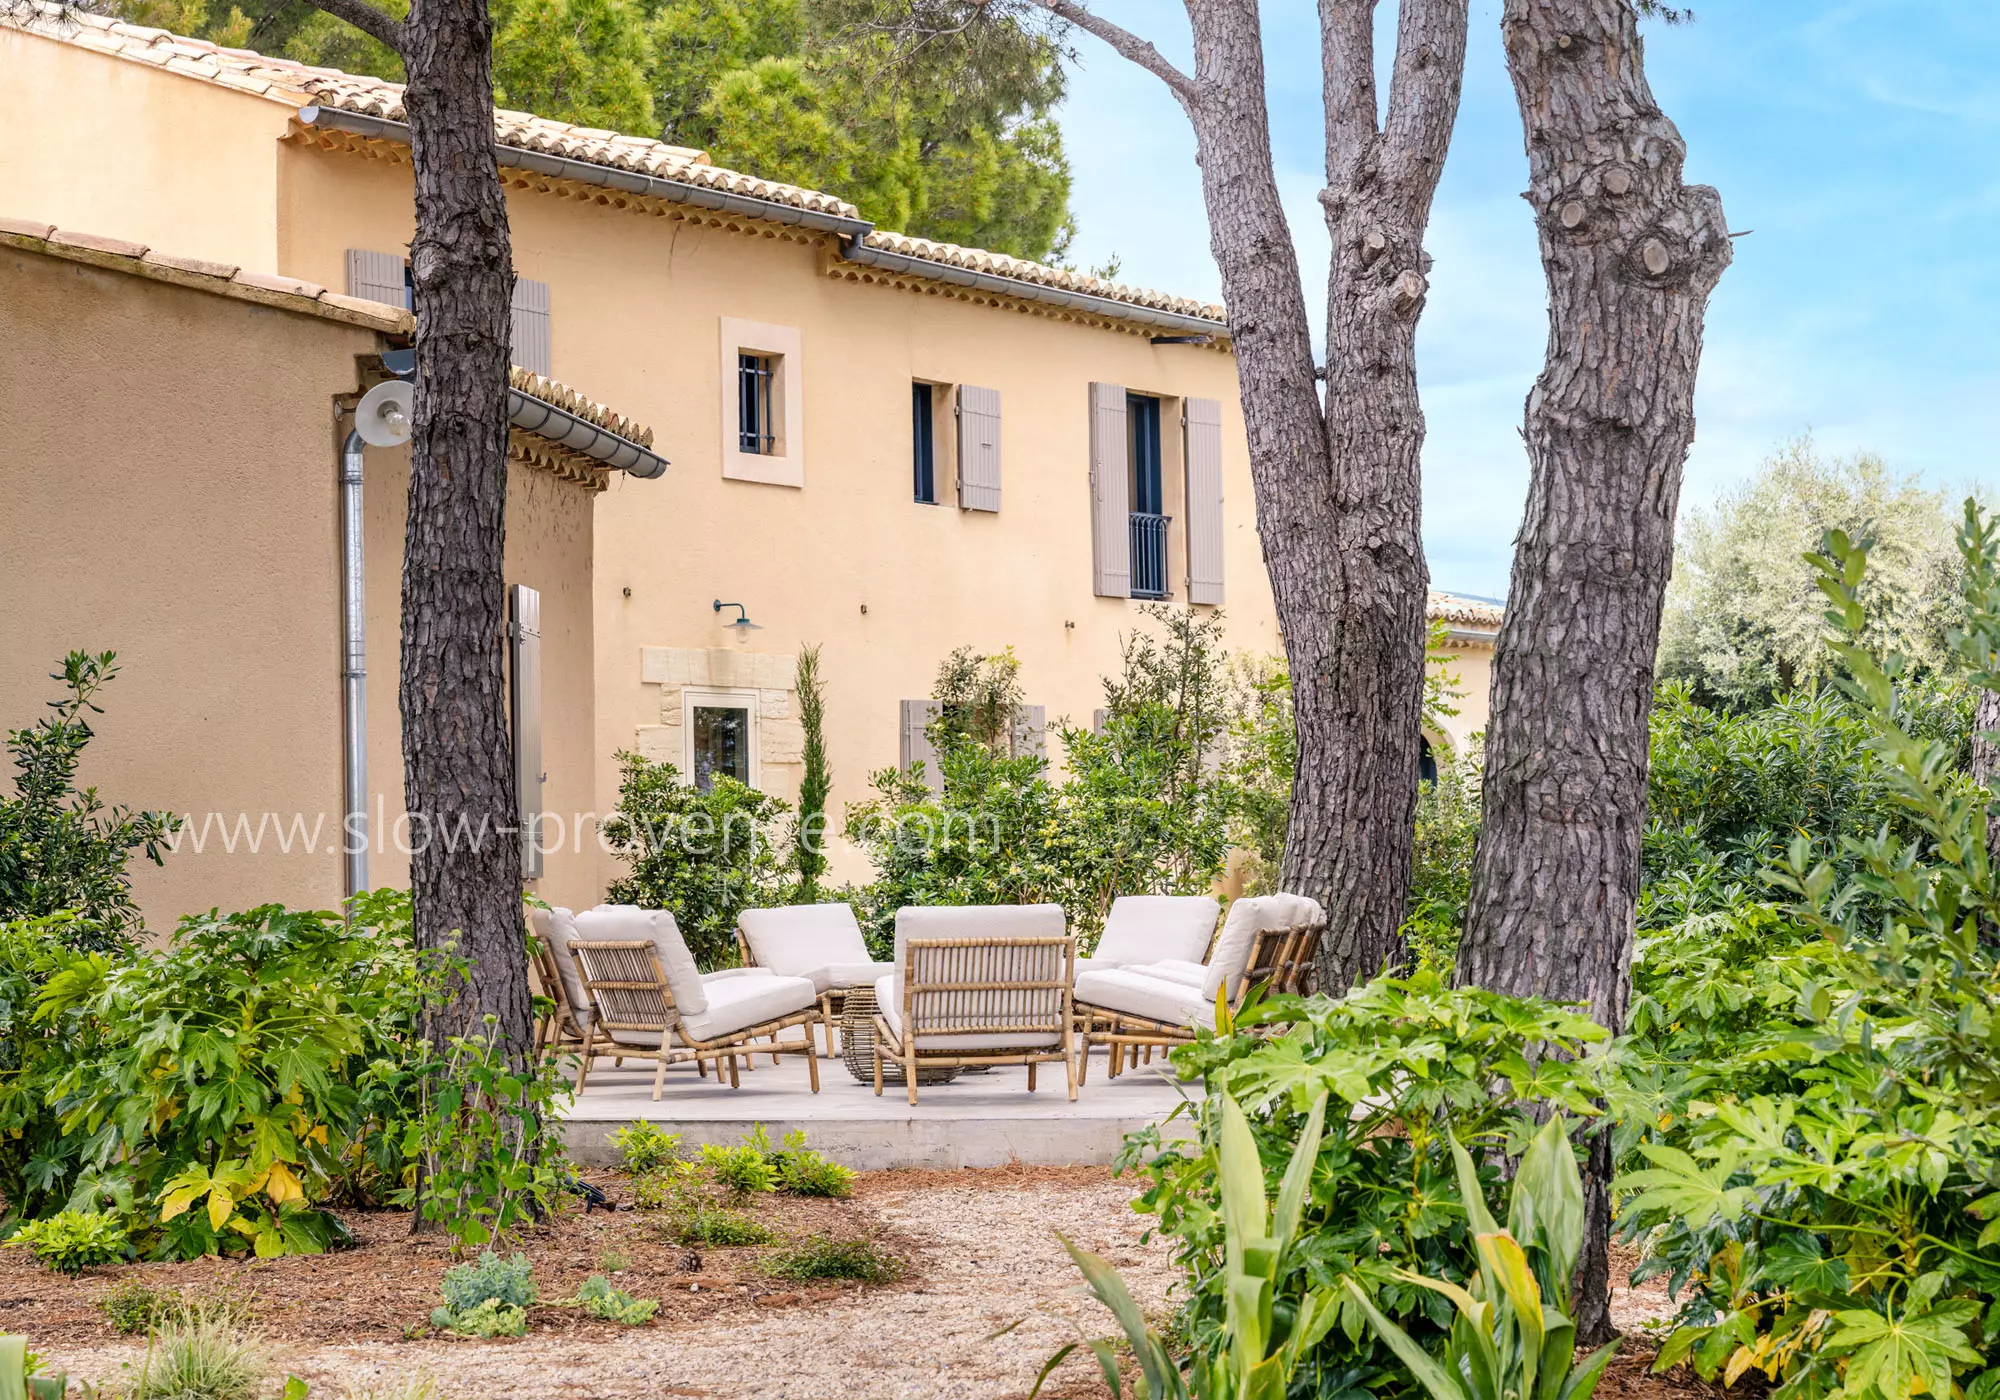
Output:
(532, 894), (1324, 1104)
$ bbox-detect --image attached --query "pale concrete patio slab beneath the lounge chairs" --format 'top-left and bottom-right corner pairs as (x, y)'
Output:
(564, 1050), (1200, 1172)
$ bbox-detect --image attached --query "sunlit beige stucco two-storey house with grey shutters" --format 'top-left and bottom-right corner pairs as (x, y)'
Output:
(0, 2), (1494, 920)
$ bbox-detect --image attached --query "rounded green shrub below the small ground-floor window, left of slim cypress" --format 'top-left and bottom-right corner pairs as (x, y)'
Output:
(604, 752), (786, 968)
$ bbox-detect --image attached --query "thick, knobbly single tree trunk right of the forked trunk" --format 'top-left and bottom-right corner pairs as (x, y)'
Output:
(1458, 0), (1730, 1340)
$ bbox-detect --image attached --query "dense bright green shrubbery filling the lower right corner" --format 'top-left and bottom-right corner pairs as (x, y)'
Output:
(1618, 504), (2000, 1400)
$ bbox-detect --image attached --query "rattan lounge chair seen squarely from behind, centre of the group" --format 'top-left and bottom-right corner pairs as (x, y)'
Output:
(874, 904), (1076, 1104)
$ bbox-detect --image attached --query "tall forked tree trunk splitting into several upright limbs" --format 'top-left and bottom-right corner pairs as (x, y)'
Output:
(1182, 0), (1466, 990)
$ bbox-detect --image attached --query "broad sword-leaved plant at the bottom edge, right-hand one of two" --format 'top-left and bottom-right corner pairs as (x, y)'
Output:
(1346, 1118), (1618, 1400)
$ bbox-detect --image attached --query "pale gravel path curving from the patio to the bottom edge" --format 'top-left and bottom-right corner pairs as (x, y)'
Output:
(48, 1174), (1172, 1400)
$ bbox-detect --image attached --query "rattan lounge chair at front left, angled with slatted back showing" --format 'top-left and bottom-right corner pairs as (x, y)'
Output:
(570, 908), (820, 1098)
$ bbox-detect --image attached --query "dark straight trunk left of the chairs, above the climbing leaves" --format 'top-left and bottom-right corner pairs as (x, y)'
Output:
(402, 0), (532, 1054)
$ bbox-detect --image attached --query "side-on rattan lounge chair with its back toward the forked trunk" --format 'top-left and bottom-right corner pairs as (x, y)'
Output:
(1076, 894), (1326, 1080)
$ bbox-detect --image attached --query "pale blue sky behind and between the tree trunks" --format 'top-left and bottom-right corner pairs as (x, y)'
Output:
(1062, 0), (2000, 596)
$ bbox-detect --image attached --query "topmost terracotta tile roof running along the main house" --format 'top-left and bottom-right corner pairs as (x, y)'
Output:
(0, 0), (1222, 330)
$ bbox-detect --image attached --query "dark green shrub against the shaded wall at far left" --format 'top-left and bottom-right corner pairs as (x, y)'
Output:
(0, 652), (180, 952)
